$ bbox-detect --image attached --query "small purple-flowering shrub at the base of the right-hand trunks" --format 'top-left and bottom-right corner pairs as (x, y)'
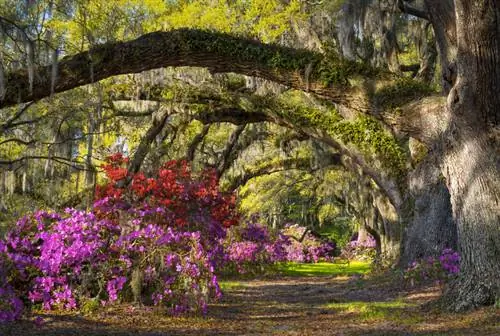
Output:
(404, 249), (460, 284)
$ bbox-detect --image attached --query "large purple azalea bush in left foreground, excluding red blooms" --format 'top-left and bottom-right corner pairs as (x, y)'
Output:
(0, 209), (221, 322)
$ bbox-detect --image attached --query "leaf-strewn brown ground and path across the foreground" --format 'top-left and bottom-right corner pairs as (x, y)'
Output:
(0, 264), (500, 336)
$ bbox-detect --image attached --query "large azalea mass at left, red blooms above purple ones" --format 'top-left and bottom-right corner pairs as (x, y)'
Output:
(0, 155), (238, 321)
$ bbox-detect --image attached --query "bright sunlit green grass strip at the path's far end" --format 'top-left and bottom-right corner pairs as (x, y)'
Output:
(276, 261), (371, 276)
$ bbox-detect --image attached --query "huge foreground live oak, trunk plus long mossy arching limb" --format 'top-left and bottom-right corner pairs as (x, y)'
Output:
(0, 0), (500, 310)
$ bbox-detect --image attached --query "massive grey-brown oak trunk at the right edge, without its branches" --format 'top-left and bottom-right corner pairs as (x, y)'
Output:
(442, 0), (500, 310)
